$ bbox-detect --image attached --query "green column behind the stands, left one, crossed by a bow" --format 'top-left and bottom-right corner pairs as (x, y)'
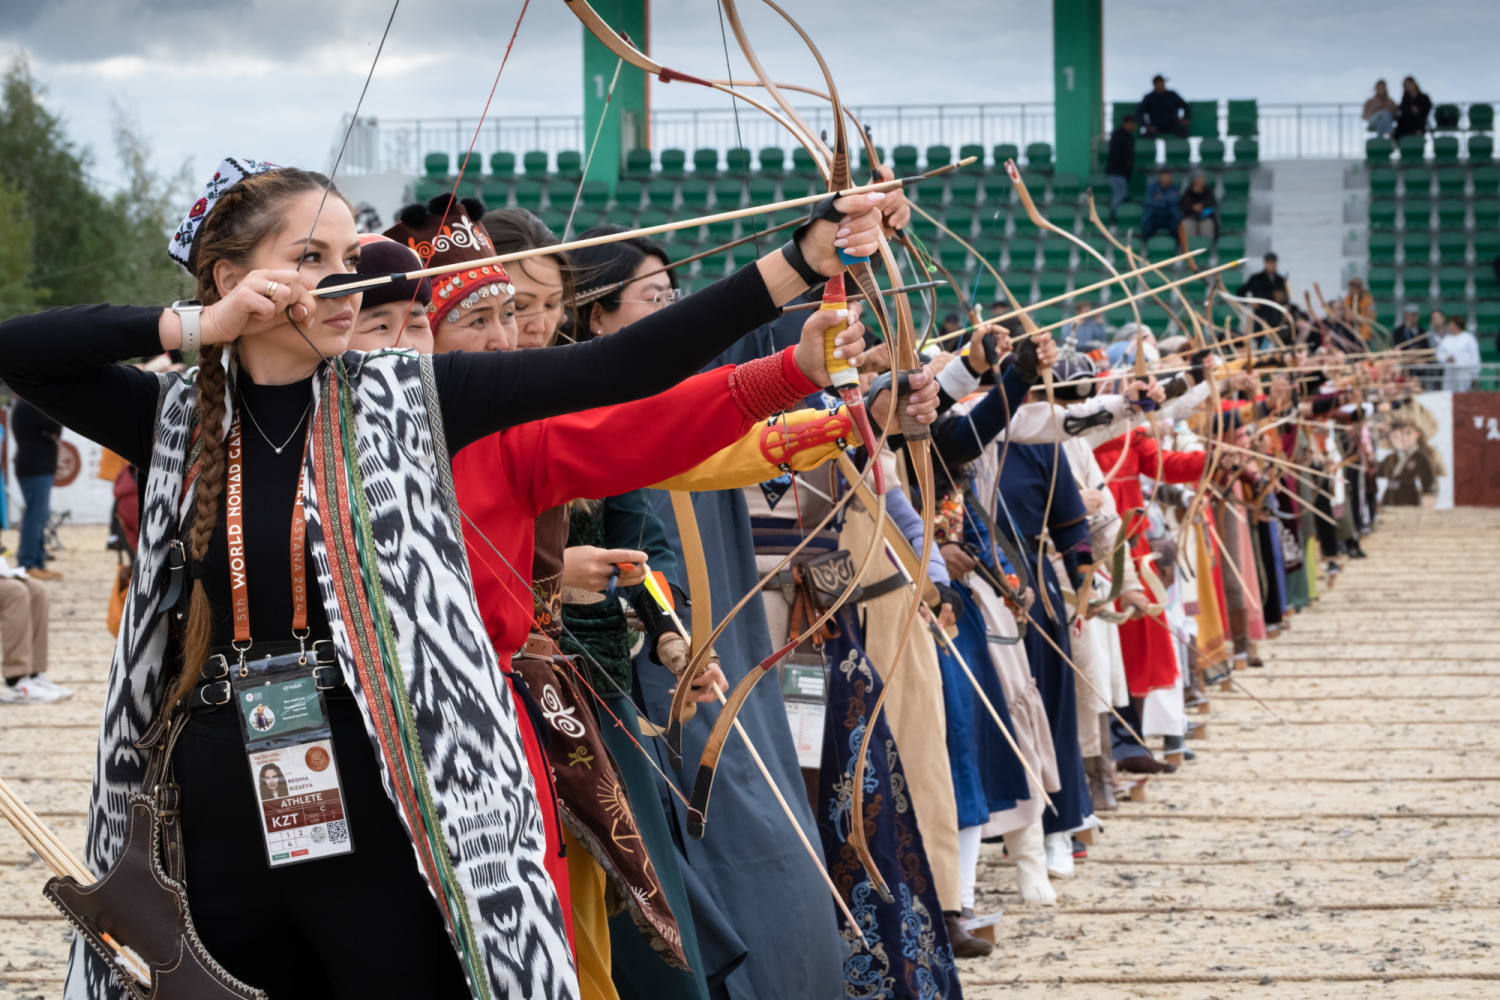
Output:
(579, 0), (651, 193)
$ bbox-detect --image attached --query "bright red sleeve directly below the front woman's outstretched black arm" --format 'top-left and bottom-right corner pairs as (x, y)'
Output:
(522, 348), (816, 511)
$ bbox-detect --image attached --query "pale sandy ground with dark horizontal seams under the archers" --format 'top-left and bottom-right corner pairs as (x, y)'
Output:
(0, 510), (1500, 1000)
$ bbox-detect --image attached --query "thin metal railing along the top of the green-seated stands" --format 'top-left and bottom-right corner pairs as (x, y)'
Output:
(330, 102), (1497, 174)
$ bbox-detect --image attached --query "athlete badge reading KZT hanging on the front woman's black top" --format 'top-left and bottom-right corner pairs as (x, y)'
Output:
(231, 654), (354, 868)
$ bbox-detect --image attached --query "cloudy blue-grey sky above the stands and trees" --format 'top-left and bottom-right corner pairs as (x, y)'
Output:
(0, 0), (1500, 193)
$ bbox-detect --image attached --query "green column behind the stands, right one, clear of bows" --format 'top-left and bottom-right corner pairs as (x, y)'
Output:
(1052, 0), (1104, 177)
